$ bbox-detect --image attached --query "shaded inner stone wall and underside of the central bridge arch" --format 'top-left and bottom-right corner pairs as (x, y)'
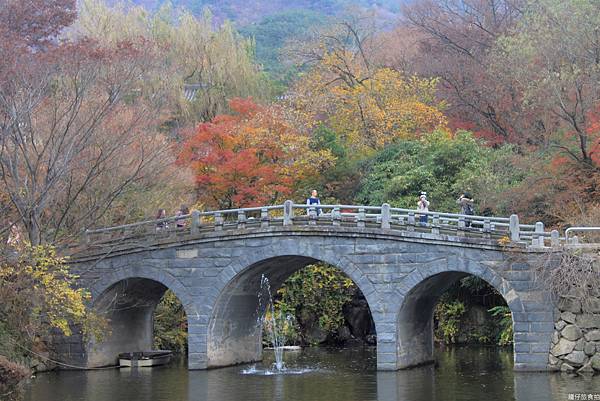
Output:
(207, 255), (377, 368)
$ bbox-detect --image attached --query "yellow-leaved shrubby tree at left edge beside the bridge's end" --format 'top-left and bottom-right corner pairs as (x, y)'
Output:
(0, 246), (106, 361)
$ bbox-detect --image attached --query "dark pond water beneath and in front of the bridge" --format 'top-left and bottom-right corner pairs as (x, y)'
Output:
(25, 346), (600, 401)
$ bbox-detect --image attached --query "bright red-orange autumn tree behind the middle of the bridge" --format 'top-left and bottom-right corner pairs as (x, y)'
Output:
(178, 98), (332, 208)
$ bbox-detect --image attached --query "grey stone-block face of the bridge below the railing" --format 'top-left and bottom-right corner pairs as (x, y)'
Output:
(64, 226), (556, 370)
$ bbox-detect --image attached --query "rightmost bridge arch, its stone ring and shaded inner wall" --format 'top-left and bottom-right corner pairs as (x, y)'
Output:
(396, 263), (524, 369)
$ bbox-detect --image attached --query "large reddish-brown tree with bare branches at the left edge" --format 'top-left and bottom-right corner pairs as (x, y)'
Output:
(0, 2), (192, 245)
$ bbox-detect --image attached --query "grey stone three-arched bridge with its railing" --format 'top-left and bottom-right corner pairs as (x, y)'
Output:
(62, 201), (572, 370)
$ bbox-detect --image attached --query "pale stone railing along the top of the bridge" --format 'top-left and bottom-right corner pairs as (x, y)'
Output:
(85, 200), (566, 247)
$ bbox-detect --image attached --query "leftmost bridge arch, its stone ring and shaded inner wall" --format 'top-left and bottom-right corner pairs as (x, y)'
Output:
(86, 268), (195, 367)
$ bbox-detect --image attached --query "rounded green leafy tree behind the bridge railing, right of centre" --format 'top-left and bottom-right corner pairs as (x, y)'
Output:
(356, 131), (524, 213)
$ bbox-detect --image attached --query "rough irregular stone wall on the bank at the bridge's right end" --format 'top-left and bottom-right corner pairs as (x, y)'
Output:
(549, 298), (600, 374)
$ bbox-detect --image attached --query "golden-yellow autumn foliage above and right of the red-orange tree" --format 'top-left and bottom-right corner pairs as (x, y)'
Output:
(289, 52), (448, 153)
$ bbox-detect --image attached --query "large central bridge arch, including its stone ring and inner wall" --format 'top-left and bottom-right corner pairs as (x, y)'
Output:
(206, 241), (378, 368)
